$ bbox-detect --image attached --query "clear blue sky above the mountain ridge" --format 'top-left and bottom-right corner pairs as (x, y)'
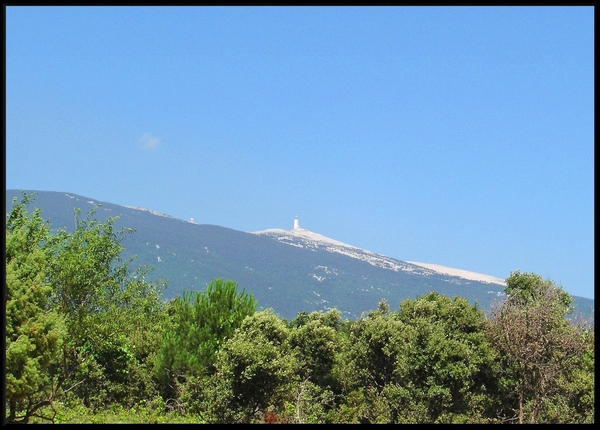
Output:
(6, 6), (594, 298)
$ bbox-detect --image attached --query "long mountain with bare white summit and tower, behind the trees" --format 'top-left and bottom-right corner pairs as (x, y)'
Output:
(6, 190), (594, 319)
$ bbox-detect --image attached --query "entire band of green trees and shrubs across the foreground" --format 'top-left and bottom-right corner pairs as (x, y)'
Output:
(5, 195), (594, 423)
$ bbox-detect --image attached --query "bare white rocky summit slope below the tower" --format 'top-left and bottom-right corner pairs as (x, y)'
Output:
(252, 227), (505, 286)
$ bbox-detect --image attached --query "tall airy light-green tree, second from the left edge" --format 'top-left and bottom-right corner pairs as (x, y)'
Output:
(50, 207), (164, 407)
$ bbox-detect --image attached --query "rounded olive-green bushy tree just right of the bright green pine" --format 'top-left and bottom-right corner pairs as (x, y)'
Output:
(188, 309), (298, 423)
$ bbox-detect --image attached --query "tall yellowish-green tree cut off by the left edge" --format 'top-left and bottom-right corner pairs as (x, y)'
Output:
(6, 195), (65, 423)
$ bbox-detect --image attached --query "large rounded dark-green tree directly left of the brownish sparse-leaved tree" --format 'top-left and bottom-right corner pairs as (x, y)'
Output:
(395, 292), (496, 423)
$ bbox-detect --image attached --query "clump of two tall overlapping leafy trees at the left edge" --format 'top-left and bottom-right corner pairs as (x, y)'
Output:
(6, 196), (164, 423)
